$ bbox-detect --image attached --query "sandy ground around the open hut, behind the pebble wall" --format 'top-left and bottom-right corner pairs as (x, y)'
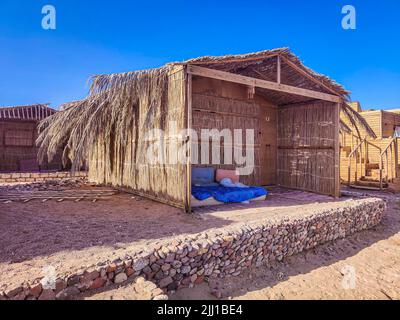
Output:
(0, 182), (350, 290)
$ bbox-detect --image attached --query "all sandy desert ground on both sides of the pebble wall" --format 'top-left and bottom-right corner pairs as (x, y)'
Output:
(0, 181), (400, 300)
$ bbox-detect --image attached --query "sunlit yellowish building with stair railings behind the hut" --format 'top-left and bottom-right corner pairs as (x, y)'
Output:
(340, 102), (400, 189)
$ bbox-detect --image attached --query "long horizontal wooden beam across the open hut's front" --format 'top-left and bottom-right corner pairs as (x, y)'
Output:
(187, 65), (342, 103)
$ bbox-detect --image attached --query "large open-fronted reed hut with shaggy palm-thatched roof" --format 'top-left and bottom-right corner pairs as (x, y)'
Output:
(39, 48), (356, 211)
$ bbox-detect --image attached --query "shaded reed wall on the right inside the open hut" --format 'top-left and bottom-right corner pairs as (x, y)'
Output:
(278, 102), (337, 195)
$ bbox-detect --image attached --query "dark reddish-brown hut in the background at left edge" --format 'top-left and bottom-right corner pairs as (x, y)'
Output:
(0, 104), (61, 172)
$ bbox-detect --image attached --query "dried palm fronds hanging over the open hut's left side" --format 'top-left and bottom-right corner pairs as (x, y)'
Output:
(37, 68), (167, 171)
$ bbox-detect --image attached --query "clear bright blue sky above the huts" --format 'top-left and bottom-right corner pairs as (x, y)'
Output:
(0, 0), (400, 108)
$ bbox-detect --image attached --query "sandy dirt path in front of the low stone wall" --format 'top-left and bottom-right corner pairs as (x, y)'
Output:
(170, 201), (400, 300)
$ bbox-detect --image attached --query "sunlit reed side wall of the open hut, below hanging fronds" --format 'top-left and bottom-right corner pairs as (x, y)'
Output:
(89, 69), (187, 207)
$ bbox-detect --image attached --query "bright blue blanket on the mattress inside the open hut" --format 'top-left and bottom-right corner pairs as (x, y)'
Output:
(192, 186), (268, 203)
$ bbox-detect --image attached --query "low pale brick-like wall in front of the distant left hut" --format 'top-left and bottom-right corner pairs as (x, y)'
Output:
(0, 171), (87, 183)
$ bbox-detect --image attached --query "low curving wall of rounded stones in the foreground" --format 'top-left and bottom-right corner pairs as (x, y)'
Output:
(0, 198), (386, 299)
